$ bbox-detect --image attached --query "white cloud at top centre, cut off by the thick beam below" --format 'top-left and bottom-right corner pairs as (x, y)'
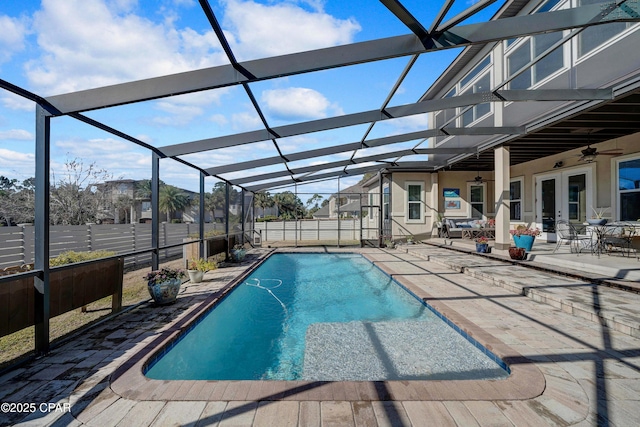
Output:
(224, 0), (361, 60)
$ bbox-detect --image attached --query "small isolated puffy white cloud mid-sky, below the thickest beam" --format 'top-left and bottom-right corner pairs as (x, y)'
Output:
(262, 87), (331, 120)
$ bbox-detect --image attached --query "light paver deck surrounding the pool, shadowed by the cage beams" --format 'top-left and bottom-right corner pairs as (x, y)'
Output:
(0, 245), (640, 426)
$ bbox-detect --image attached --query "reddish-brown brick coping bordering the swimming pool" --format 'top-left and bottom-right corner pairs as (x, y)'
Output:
(110, 249), (545, 401)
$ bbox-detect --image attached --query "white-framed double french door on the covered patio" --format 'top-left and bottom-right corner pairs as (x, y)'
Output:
(535, 168), (593, 242)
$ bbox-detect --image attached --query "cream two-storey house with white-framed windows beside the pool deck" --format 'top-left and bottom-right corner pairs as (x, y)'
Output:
(364, 0), (640, 249)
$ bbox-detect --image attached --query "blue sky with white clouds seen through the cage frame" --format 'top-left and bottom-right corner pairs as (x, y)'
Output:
(0, 0), (504, 197)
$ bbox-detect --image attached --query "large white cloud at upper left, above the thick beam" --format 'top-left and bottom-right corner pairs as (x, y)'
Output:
(26, 0), (228, 94)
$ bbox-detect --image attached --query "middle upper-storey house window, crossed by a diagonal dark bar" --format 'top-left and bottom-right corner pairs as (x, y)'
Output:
(507, 31), (564, 89)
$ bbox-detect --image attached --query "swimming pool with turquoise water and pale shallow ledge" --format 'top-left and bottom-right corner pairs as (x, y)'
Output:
(145, 253), (508, 380)
